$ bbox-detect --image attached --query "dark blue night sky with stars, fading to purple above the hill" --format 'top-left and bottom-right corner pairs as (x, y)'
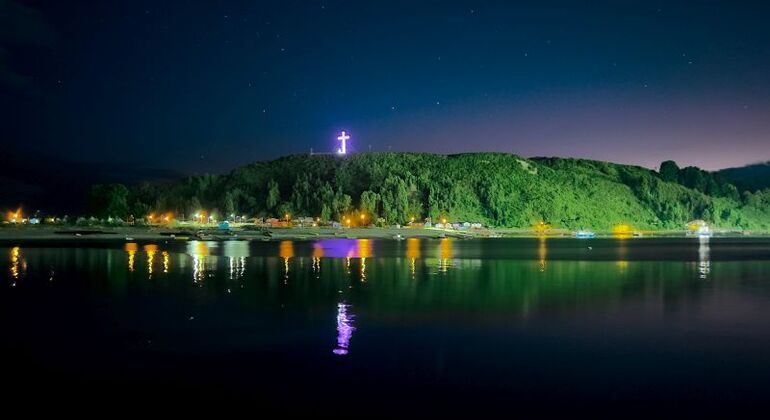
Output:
(0, 0), (770, 173)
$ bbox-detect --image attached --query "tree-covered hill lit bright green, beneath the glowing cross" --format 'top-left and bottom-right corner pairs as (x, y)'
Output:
(100, 153), (770, 230)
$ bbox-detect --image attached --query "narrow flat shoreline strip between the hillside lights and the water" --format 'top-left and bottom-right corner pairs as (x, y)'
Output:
(0, 226), (770, 244)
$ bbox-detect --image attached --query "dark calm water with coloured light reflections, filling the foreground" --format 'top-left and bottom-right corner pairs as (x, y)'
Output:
(0, 239), (770, 416)
